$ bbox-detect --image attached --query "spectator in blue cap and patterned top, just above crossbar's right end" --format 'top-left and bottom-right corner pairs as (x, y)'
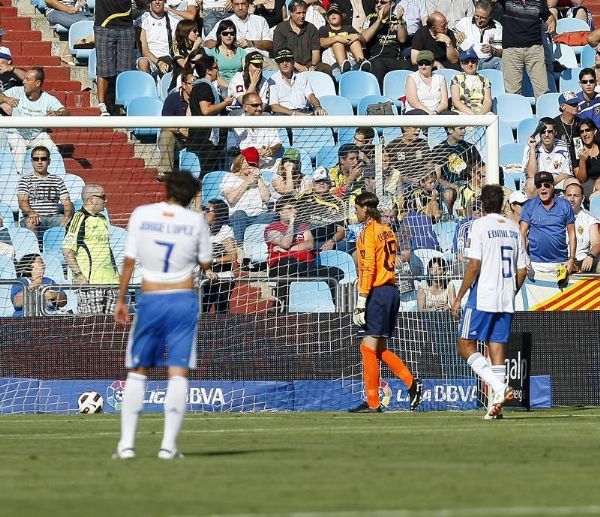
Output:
(450, 48), (492, 115)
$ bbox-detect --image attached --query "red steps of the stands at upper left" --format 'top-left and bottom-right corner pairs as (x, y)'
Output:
(0, 0), (163, 226)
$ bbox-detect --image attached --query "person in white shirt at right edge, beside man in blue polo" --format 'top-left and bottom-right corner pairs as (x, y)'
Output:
(564, 178), (600, 273)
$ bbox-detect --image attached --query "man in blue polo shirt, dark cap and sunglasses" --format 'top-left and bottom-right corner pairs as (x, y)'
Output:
(519, 171), (577, 273)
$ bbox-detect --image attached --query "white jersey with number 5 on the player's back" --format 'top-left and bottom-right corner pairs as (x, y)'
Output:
(466, 214), (526, 312)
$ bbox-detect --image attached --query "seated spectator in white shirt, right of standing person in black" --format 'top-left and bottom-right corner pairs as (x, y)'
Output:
(137, 0), (179, 77)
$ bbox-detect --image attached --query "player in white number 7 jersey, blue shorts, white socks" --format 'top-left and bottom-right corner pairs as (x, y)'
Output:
(113, 173), (212, 459)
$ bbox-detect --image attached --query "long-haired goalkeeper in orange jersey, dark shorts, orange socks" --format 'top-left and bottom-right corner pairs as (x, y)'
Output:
(350, 192), (423, 413)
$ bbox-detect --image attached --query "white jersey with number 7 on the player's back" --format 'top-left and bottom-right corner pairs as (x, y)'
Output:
(125, 202), (212, 284)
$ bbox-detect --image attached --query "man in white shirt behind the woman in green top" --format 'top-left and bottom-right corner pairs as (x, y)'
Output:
(204, 0), (273, 61)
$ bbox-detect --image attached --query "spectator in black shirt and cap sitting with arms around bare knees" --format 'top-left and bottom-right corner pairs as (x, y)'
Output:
(319, 4), (370, 75)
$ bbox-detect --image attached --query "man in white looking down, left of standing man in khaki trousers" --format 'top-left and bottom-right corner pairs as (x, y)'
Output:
(455, 0), (502, 70)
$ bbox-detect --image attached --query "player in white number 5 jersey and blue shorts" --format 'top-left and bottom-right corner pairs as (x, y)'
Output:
(450, 185), (527, 419)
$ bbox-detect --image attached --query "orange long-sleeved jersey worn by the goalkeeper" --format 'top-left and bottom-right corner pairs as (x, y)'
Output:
(356, 220), (398, 296)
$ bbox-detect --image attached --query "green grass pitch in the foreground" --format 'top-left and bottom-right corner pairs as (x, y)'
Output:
(0, 408), (600, 517)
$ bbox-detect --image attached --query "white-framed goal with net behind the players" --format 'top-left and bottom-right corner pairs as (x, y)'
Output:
(0, 116), (498, 413)
